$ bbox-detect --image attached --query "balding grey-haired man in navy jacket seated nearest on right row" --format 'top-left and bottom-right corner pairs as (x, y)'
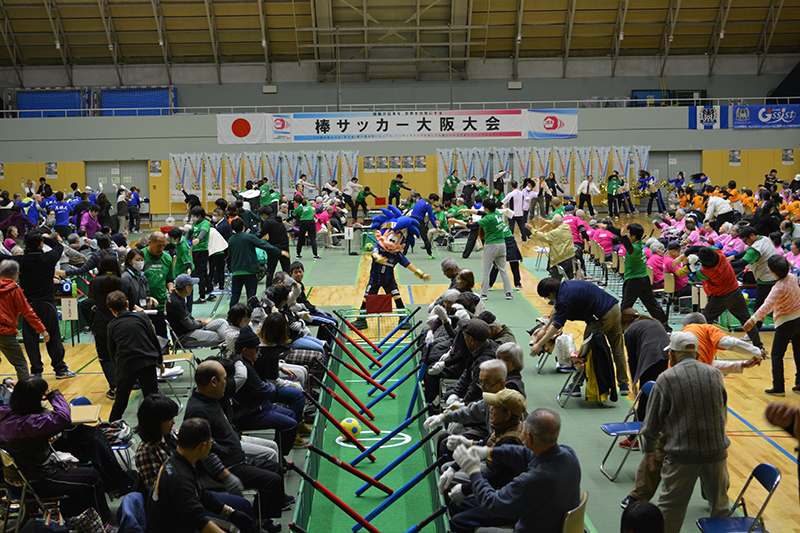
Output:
(453, 408), (581, 533)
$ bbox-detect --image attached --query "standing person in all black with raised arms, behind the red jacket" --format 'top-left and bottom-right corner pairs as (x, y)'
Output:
(2, 231), (75, 379)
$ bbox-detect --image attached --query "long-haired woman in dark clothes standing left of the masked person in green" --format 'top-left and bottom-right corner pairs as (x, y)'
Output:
(89, 254), (122, 400)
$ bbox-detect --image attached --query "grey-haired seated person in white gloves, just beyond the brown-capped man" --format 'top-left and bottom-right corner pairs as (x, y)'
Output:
(423, 359), (508, 457)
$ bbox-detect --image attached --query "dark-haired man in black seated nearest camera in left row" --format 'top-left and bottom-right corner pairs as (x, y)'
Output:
(145, 418), (257, 533)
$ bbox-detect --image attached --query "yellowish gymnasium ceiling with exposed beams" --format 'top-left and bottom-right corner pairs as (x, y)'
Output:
(0, 0), (800, 84)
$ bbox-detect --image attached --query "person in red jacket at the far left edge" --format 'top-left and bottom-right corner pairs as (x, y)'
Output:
(0, 261), (50, 380)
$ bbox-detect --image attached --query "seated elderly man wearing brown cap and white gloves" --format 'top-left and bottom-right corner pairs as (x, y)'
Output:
(438, 389), (527, 532)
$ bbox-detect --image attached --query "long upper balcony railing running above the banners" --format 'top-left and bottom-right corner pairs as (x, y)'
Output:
(2, 97), (798, 118)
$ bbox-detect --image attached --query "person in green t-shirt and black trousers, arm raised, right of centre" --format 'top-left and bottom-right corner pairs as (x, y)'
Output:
(607, 222), (671, 336)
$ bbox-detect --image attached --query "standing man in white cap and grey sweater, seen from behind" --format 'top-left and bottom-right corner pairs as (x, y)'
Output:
(642, 331), (730, 533)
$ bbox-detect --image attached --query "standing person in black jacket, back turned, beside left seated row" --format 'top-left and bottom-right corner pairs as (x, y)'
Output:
(106, 290), (164, 422)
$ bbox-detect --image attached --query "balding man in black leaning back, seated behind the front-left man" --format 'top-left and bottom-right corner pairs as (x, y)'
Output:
(186, 361), (293, 533)
